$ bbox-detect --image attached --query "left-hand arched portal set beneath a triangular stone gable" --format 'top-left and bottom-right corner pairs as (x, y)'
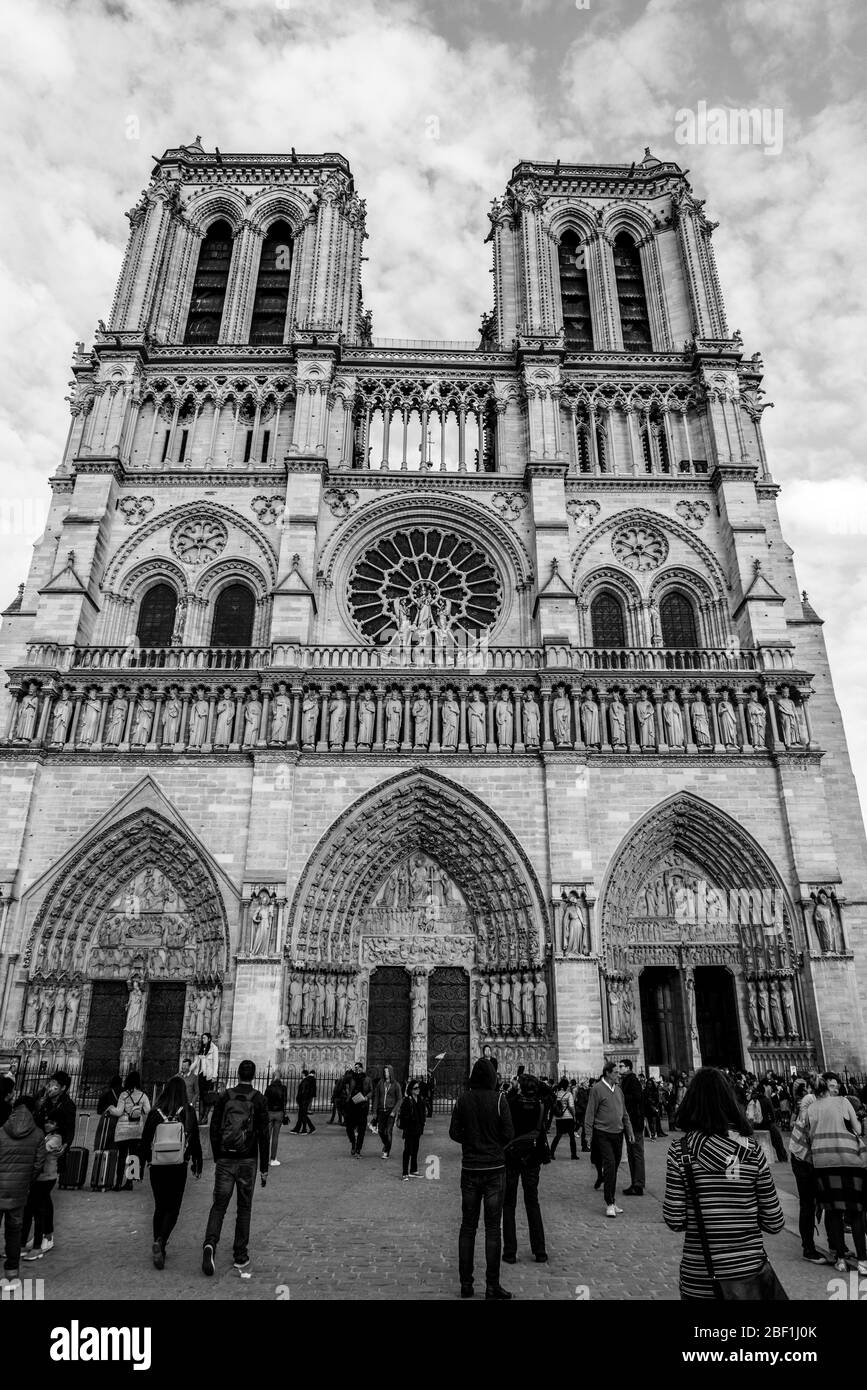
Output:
(19, 810), (229, 1088)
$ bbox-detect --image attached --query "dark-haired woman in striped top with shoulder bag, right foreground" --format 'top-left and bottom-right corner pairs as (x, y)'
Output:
(663, 1066), (785, 1300)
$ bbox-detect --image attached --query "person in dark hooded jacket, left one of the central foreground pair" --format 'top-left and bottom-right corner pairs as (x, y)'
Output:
(449, 1058), (514, 1300)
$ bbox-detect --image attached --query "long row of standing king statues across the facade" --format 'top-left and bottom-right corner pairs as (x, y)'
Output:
(4, 664), (816, 756)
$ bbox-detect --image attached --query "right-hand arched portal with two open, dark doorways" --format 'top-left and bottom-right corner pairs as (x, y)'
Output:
(602, 792), (816, 1074)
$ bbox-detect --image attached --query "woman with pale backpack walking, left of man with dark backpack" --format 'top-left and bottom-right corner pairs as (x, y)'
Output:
(142, 1074), (201, 1269)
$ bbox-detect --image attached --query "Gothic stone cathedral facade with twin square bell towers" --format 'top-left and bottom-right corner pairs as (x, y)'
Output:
(0, 138), (867, 1084)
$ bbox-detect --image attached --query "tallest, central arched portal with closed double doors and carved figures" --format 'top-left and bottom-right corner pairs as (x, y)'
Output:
(282, 770), (553, 1084)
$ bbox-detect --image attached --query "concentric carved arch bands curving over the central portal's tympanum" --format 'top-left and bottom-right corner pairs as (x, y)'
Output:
(289, 769), (550, 967)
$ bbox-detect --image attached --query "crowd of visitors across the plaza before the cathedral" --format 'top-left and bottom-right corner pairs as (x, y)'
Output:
(0, 1038), (867, 1300)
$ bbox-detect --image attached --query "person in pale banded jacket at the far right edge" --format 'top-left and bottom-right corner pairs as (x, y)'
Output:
(803, 1072), (867, 1275)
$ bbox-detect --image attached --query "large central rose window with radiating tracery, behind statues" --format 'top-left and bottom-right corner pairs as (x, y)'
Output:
(347, 527), (503, 642)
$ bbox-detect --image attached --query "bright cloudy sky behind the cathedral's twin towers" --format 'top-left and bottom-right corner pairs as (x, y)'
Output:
(0, 0), (867, 796)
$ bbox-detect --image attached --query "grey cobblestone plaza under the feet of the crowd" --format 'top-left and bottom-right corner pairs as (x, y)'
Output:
(22, 1116), (834, 1301)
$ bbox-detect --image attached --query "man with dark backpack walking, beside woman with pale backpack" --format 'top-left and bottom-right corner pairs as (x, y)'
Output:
(201, 1061), (270, 1275)
